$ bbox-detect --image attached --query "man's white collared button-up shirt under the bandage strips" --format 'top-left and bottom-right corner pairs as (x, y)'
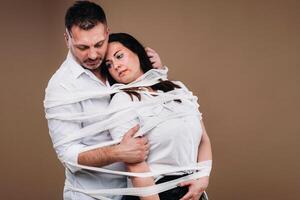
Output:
(45, 52), (126, 200)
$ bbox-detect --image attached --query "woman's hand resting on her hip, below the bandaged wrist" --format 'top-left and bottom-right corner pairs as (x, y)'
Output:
(179, 176), (209, 200)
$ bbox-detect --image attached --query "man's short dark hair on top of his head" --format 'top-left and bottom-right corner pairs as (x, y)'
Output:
(65, 1), (107, 32)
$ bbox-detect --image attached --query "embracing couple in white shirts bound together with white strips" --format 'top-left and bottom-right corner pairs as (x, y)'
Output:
(44, 1), (212, 200)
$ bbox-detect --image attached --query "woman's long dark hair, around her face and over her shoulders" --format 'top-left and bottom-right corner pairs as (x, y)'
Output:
(100, 33), (180, 100)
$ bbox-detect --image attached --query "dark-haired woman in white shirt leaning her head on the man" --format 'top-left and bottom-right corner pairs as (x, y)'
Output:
(101, 33), (212, 200)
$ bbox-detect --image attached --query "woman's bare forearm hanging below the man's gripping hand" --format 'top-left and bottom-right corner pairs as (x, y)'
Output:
(126, 161), (159, 200)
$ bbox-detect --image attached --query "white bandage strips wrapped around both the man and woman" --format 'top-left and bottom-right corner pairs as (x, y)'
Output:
(44, 69), (212, 200)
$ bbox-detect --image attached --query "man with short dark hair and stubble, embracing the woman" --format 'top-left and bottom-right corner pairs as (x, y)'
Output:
(45, 1), (161, 200)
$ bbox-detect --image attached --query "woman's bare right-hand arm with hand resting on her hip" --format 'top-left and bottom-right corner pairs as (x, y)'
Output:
(180, 120), (212, 200)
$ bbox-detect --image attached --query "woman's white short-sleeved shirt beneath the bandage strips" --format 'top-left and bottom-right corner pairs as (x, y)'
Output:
(109, 82), (202, 177)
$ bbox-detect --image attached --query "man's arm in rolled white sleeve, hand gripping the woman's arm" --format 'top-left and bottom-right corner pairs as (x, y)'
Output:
(46, 96), (149, 172)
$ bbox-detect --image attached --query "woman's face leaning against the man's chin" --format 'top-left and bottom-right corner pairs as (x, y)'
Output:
(105, 42), (143, 84)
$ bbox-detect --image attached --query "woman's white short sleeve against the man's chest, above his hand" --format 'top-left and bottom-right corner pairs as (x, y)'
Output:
(109, 92), (139, 140)
